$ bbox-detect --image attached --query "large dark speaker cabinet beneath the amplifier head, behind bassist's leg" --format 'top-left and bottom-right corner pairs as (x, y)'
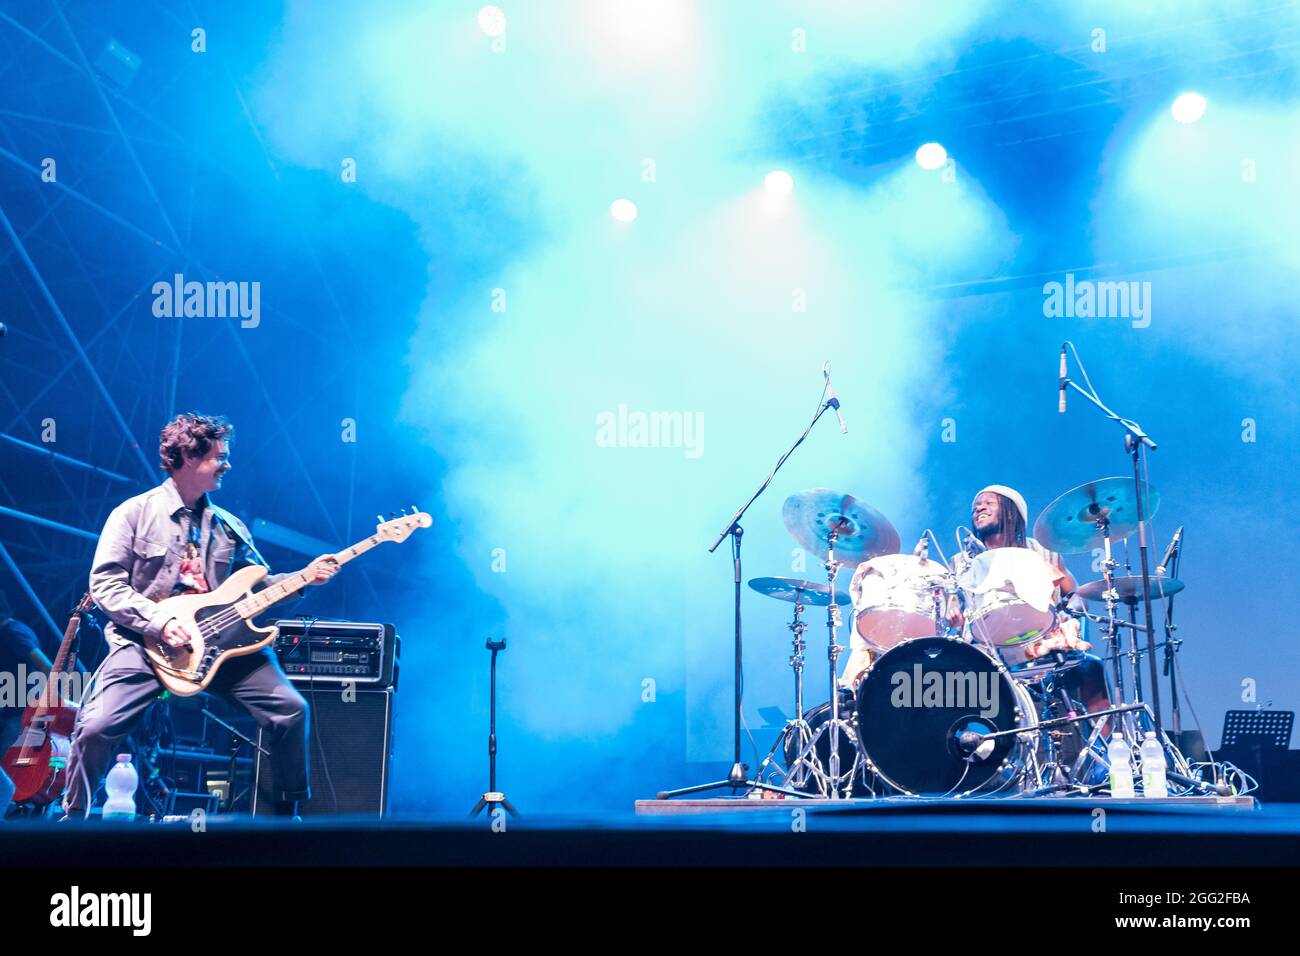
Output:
(252, 679), (397, 817)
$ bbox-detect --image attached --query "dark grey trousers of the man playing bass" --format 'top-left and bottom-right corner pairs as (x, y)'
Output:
(64, 644), (311, 814)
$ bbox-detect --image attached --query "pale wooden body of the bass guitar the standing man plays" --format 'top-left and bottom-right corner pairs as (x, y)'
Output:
(144, 564), (278, 697)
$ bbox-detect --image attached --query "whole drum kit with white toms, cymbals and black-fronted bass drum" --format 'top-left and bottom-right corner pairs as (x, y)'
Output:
(749, 479), (1196, 800)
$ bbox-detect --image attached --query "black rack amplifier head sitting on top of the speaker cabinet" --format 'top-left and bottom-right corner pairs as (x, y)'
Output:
(274, 618), (402, 688)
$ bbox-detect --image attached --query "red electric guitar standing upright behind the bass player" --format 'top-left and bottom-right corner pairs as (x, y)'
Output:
(0, 592), (95, 806)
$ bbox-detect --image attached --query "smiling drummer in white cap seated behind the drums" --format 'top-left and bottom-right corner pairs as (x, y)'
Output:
(949, 485), (1110, 731)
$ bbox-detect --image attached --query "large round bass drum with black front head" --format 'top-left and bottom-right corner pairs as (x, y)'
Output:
(858, 637), (1035, 796)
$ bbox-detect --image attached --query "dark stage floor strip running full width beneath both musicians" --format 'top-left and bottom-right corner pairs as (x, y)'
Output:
(0, 799), (1300, 868)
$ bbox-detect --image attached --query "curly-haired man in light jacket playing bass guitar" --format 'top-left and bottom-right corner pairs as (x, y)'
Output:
(64, 414), (338, 817)
